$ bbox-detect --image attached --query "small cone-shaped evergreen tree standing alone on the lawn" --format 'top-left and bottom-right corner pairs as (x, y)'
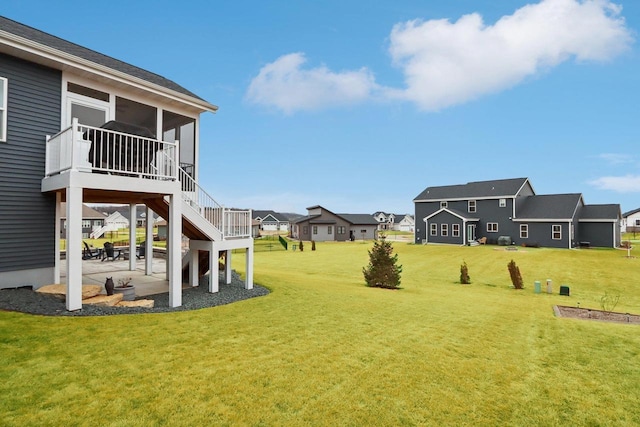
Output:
(362, 236), (402, 289)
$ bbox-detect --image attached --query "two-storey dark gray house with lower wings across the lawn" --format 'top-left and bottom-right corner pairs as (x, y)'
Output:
(413, 178), (621, 248)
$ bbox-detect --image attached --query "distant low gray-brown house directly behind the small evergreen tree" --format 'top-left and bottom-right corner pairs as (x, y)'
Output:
(291, 205), (378, 242)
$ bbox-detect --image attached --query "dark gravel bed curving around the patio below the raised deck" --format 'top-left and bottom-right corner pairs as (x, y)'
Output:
(0, 271), (269, 316)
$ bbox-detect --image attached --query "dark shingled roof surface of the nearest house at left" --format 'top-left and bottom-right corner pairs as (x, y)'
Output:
(0, 16), (207, 102)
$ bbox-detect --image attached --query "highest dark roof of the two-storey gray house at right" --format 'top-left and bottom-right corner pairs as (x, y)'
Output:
(413, 178), (528, 202)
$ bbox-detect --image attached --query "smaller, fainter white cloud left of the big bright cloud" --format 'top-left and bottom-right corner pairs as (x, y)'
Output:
(247, 53), (376, 114)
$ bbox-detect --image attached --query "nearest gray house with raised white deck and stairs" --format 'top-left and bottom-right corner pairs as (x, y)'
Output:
(0, 16), (253, 310)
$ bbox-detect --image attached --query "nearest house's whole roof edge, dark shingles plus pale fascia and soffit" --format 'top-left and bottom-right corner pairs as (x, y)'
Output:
(0, 16), (218, 112)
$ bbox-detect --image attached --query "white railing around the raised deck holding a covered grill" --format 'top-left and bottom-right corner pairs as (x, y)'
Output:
(45, 119), (179, 179)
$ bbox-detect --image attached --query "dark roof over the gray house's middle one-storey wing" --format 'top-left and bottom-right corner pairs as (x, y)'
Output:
(516, 193), (582, 220)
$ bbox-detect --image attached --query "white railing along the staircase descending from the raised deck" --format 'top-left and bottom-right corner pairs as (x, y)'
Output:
(179, 168), (251, 239)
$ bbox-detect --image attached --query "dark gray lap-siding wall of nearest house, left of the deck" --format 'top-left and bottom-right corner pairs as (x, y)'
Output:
(0, 54), (61, 288)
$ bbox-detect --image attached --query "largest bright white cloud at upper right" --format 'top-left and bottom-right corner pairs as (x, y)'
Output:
(390, 0), (632, 111)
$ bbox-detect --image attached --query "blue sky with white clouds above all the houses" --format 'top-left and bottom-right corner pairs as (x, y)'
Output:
(0, 0), (640, 214)
